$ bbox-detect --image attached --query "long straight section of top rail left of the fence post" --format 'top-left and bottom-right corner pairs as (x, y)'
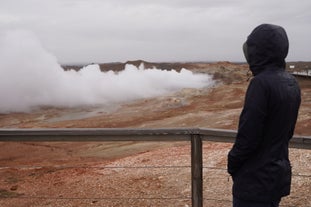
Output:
(0, 128), (199, 142)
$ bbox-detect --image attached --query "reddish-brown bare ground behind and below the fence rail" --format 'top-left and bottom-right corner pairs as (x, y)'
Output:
(0, 63), (311, 207)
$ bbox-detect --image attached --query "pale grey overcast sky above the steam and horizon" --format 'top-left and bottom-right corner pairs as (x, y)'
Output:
(0, 0), (311, 63)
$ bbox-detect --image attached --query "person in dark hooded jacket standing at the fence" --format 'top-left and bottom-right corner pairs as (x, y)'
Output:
(227, 24), (301, 207)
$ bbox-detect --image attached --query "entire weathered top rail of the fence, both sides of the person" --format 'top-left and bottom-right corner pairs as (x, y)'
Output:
(0, 128), (311, 149)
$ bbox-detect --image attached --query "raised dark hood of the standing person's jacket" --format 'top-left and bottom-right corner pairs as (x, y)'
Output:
(243, 24), (289, 75)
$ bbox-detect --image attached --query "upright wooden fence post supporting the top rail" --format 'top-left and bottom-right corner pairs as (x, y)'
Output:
(191, 134), (203, 207)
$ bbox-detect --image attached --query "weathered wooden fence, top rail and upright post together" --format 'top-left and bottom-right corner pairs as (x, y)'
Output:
(0, 128), (311, 207)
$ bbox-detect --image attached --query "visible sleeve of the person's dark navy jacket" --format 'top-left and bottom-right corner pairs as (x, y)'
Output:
(227, 77), (268, 175)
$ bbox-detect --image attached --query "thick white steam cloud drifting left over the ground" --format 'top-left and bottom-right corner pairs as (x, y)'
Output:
(0, 31), (213, 113)
